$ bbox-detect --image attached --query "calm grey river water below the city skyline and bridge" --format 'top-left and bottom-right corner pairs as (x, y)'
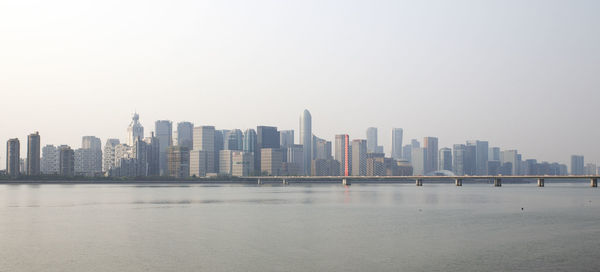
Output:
(0, 182), (600, 271)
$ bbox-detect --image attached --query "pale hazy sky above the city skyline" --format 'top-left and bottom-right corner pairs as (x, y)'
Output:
(0, 0), (600, 168)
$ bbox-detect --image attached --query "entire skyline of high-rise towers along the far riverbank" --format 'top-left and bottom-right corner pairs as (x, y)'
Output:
(6, 110), (598, 178)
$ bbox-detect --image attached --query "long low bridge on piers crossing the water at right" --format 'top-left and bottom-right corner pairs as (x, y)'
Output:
(243, 175), (600, 187)
